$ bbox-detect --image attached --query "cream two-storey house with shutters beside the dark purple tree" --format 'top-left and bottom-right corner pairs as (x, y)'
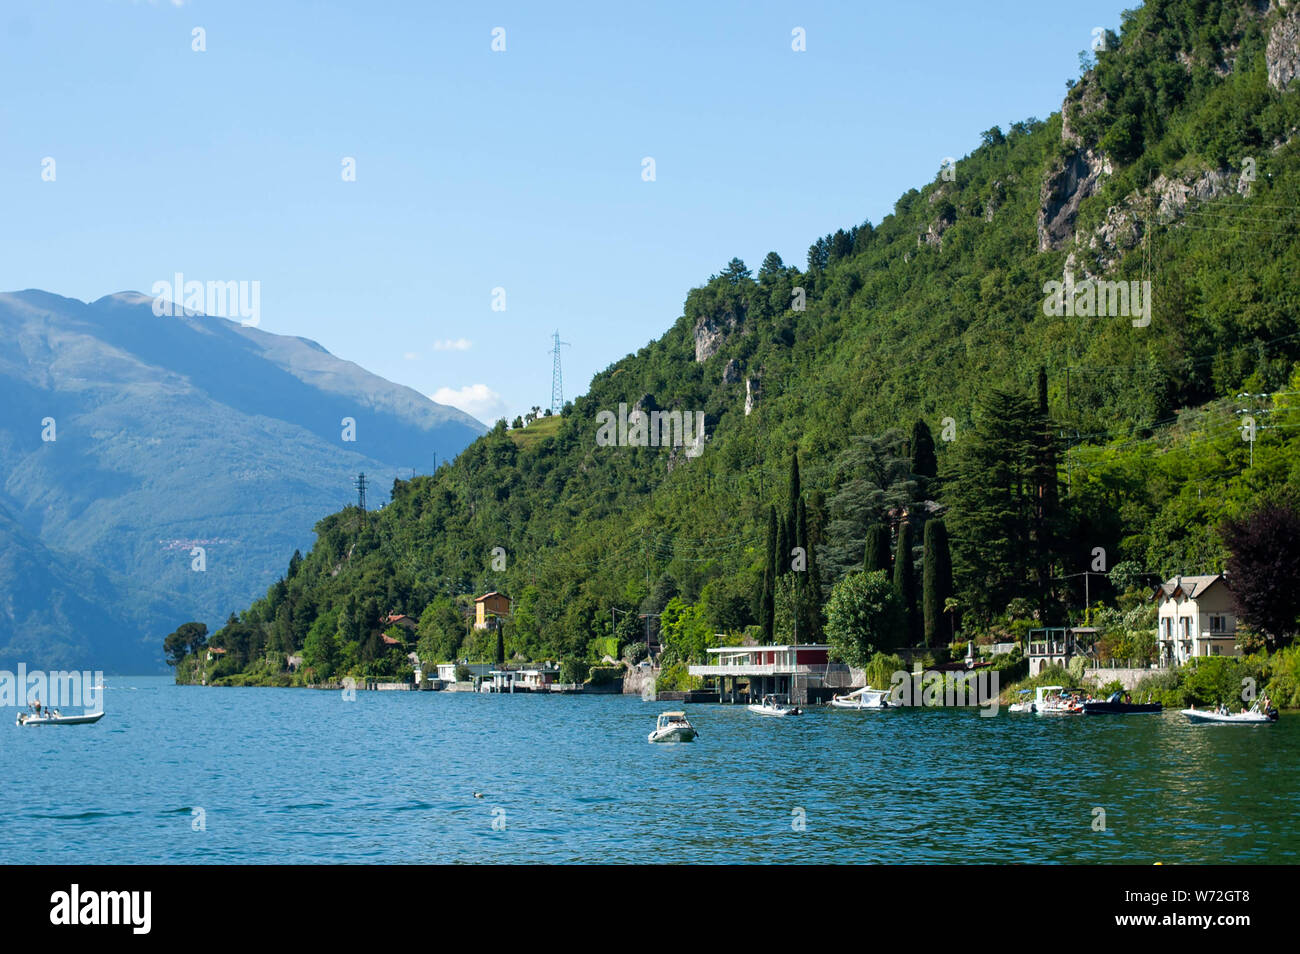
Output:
(1152, 573), (1239, 665)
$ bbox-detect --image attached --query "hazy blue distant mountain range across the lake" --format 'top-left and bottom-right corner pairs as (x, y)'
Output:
(0, 290), (485, 672)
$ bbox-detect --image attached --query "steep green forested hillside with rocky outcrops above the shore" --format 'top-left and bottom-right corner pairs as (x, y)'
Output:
(185, 0), (1300, 678)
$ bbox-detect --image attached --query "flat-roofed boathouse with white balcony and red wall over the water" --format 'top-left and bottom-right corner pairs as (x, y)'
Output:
(686, 643), (852, 706)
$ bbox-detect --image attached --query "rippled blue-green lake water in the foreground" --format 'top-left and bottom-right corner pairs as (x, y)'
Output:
(0, 676), (1300, 864)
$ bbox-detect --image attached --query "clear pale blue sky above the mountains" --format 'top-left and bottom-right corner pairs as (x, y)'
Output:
(0, 0), (1132, 421)
